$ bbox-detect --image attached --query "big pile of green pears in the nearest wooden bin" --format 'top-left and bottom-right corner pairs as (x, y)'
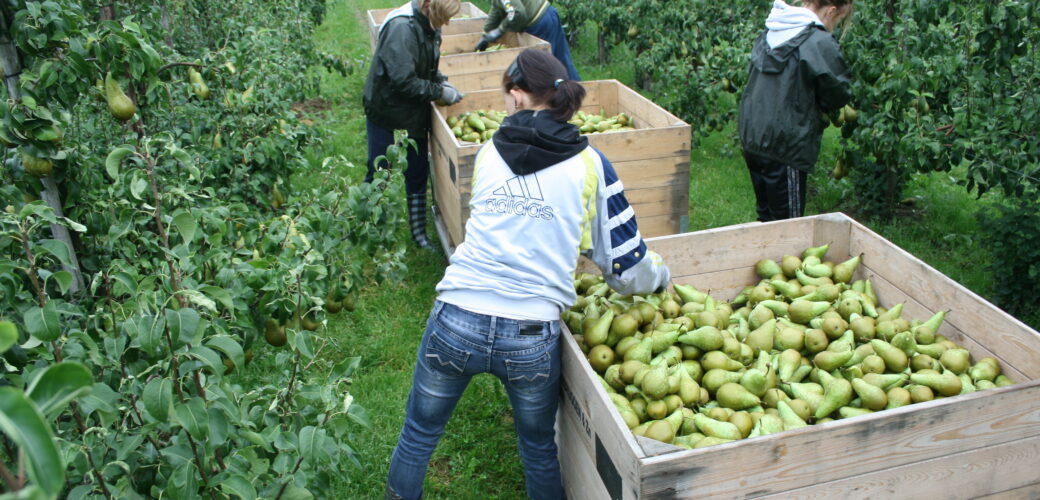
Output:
(563, 244), (1013, 448)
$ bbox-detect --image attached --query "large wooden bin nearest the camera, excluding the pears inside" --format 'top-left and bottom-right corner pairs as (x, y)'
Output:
(557, 214), (1040, 500)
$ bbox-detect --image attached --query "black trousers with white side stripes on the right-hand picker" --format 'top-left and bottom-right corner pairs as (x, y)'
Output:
(744, 153), (808, 222)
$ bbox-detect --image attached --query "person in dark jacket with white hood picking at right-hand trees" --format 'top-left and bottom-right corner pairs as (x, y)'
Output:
(737, 0), (852, 222)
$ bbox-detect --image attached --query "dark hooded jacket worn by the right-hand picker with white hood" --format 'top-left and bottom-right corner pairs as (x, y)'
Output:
(737, 25), (852, 172)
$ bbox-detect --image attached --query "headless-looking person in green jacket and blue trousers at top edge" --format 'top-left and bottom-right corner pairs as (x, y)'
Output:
(474, 0), (581, 80)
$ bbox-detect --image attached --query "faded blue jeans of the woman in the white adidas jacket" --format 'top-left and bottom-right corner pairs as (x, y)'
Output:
(387, 300), (564, 500)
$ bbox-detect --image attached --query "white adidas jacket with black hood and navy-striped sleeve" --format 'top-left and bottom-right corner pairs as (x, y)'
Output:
(437, 110), (671, 321)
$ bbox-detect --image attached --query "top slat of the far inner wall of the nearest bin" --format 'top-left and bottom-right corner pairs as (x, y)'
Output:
(647, 217), (813, 275)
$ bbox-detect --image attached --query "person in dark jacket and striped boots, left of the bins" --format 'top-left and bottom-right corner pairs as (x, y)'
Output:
(364, 0), (463, 248)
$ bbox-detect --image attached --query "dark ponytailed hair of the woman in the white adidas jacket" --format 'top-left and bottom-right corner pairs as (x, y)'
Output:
(502, 49), (586, 122)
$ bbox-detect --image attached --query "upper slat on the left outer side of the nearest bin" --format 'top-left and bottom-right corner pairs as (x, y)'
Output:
(561, 325), (643, 499)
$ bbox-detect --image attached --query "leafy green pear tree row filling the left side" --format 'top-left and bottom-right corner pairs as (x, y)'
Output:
(0, 0), (405, 498)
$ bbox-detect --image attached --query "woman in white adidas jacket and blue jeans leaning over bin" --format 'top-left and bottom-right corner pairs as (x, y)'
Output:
(387, 50), (671, 499)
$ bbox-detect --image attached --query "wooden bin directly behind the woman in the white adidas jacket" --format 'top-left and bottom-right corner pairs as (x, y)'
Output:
(430, 80), (690, 251)
